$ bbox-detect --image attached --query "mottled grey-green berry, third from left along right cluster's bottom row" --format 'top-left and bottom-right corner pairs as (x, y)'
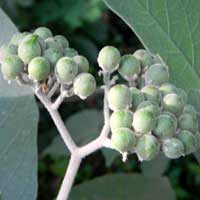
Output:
(162, 138), (184, 159)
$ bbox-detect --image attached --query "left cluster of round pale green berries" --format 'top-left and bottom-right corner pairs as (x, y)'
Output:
(0, 27), (96, 99)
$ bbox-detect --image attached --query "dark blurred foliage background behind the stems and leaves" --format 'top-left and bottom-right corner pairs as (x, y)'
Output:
(0, 0), (200, 200)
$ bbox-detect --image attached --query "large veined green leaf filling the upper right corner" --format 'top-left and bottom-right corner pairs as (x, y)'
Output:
(104, 0), (200, 163)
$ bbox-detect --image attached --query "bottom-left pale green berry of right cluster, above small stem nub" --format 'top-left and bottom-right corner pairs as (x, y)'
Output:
(111, 128), (136, 153)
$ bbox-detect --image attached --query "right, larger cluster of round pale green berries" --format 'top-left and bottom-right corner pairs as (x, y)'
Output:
(98, 46), (200, 161)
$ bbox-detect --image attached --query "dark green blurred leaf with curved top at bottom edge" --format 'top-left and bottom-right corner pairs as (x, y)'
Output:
(69, 174), (175, 200)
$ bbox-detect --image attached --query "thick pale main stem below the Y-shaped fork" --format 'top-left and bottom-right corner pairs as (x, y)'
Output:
(57, 153), (82, 200)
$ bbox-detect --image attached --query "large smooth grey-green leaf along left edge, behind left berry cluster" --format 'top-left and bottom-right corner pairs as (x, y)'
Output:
(0, 9), (38, 200)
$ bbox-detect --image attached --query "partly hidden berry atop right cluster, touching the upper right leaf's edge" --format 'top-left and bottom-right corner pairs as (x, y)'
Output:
(133, 49), (153, 68)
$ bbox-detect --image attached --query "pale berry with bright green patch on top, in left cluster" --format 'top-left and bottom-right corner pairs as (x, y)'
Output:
(18, 34), (42, 64)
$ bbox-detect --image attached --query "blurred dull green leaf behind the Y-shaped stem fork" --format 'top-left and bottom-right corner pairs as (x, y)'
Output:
(42, 109), (103, 157)
